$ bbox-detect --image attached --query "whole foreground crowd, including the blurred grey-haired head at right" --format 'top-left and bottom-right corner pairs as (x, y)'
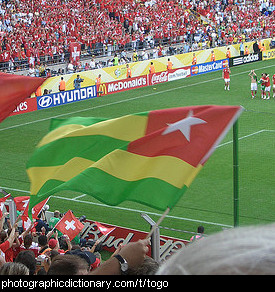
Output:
(0, 202), (275, 279)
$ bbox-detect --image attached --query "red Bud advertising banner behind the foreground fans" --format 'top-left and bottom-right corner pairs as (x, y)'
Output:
(81, 220), (189, 260)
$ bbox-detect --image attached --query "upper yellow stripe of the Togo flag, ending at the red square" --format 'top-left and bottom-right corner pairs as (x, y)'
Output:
(37, 115), (148, 148)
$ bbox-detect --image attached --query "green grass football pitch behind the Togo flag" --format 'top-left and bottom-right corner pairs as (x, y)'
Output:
(0, 60), (275, 239)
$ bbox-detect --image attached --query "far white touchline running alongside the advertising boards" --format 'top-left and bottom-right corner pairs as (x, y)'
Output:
(0, 65), (275, 132)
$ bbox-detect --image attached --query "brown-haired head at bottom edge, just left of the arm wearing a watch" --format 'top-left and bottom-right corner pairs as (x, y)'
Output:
(47, 254), (90, 275)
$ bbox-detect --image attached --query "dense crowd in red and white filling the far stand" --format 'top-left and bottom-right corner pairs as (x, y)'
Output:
(0, 0), (275, 69)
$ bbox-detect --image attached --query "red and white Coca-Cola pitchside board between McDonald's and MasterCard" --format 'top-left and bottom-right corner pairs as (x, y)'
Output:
(149, 66), (191, 85)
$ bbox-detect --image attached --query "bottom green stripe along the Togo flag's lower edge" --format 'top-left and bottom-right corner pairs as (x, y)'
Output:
(31, 168), (190, 211)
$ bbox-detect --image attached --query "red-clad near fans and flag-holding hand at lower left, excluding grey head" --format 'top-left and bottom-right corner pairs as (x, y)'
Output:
(0, 210), (159, 275)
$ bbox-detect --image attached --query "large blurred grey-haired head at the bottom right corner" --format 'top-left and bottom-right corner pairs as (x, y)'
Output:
(157, 223), (275, 275)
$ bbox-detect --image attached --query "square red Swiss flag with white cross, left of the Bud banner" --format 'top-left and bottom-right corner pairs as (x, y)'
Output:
(55, 210), (84, 241)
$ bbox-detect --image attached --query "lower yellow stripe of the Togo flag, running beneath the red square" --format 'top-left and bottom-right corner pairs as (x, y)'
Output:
(27, 149), (202, 194)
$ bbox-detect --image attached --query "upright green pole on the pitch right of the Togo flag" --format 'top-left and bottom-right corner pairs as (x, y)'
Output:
(233, 120), (239, 227)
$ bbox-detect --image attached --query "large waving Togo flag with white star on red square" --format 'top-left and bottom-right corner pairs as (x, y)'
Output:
(27, 105), (242, 210)
